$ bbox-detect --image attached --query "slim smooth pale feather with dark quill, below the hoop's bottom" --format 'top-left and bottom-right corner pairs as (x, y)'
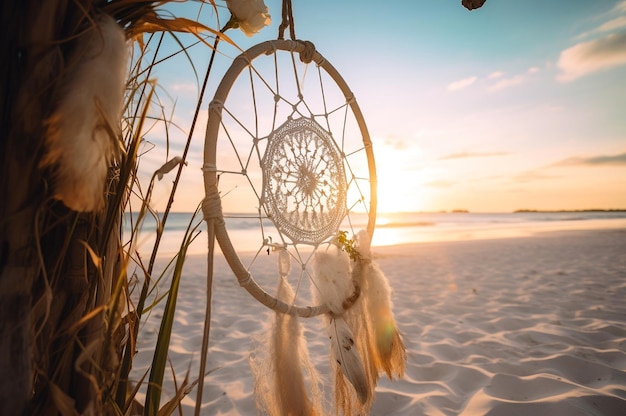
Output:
(328, 316), (370, 403)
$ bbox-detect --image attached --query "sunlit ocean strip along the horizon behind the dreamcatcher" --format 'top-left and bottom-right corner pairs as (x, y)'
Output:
(124, 211), (626, 256)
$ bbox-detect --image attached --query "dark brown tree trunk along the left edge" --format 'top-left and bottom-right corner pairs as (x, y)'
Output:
(0, 0), (110, 415)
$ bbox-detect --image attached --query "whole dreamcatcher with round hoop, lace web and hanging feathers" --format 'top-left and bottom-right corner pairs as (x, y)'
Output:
(203, 0), (405, 415)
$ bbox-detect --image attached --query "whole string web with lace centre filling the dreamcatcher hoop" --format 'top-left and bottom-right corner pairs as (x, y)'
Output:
(211, 41), (370, 301)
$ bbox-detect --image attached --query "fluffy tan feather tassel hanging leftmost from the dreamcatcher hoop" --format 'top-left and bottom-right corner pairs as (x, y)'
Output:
(250, 250), (323, 416)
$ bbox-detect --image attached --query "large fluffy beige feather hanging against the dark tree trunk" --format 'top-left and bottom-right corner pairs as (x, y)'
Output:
(40, 15), (128, 212)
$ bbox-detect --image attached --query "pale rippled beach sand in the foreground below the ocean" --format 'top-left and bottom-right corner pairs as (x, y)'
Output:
(133, 230), (626, 416)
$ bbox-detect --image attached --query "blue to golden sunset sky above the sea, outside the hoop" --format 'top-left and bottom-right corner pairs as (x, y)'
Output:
(142, 0), (626, 212)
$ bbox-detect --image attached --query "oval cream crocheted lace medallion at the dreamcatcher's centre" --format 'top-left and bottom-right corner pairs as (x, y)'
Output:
(261, 118), (346, 244)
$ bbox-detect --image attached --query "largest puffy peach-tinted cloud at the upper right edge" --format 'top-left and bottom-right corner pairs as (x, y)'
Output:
(557, 31), (626, 82)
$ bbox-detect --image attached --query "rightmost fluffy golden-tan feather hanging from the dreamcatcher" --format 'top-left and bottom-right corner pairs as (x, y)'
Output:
(353, 231), (406, 379)
